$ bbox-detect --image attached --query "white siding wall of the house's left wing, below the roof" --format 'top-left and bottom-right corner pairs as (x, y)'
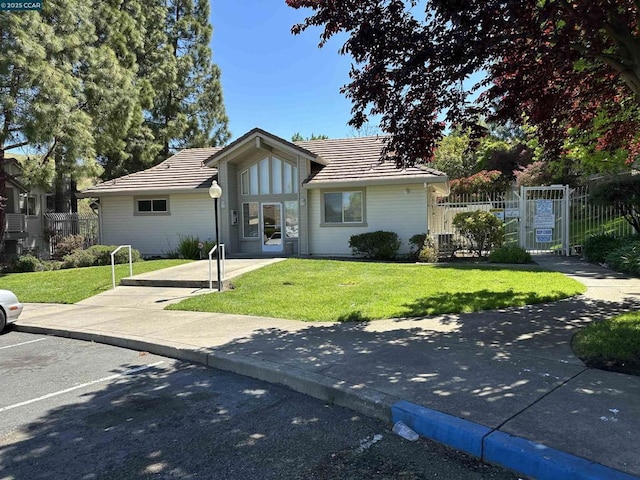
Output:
(100, 192), (216, 256)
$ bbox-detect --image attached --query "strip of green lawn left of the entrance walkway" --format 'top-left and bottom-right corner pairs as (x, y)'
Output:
(0, 260), (190, 303)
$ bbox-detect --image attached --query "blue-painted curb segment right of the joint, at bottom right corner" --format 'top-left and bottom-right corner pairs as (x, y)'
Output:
(483, 431), (638, 480)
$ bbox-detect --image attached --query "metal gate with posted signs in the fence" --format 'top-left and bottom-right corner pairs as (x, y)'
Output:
(519, 185), (571, 255)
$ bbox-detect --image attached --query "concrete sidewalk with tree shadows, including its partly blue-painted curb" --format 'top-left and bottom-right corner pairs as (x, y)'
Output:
(12, 257), (640, 479)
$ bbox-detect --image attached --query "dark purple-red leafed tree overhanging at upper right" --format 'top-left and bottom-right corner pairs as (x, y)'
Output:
(287, 0), (640, 165)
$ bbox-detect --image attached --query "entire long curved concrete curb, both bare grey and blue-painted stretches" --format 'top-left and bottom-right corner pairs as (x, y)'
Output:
(13, 324), (640, 480)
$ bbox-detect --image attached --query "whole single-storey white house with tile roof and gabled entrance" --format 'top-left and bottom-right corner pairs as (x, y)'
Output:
(80, 128), (448, 256)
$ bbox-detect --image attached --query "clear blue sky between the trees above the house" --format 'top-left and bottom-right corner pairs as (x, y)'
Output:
(210, 0), (362, 140)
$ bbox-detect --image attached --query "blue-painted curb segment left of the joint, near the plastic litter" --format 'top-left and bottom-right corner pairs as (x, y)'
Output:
(391, 400), (491, 458)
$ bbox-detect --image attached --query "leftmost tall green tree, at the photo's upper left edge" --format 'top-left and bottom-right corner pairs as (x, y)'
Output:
(0, 0), (95, 244)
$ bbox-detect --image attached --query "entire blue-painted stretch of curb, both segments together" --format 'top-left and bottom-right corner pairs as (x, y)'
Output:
(391, 400), (638, 480)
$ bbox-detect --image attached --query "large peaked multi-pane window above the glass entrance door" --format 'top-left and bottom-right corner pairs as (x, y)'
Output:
(240, 157), (298, 195)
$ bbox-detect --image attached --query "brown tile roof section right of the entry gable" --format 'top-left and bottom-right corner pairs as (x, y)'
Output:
(296, 137), (446, 186)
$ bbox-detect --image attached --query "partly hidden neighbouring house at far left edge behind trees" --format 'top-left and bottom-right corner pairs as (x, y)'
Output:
(3, 157), (48, 255)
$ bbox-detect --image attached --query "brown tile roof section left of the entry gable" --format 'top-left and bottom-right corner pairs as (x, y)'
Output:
(81, 147), (221, 197)
